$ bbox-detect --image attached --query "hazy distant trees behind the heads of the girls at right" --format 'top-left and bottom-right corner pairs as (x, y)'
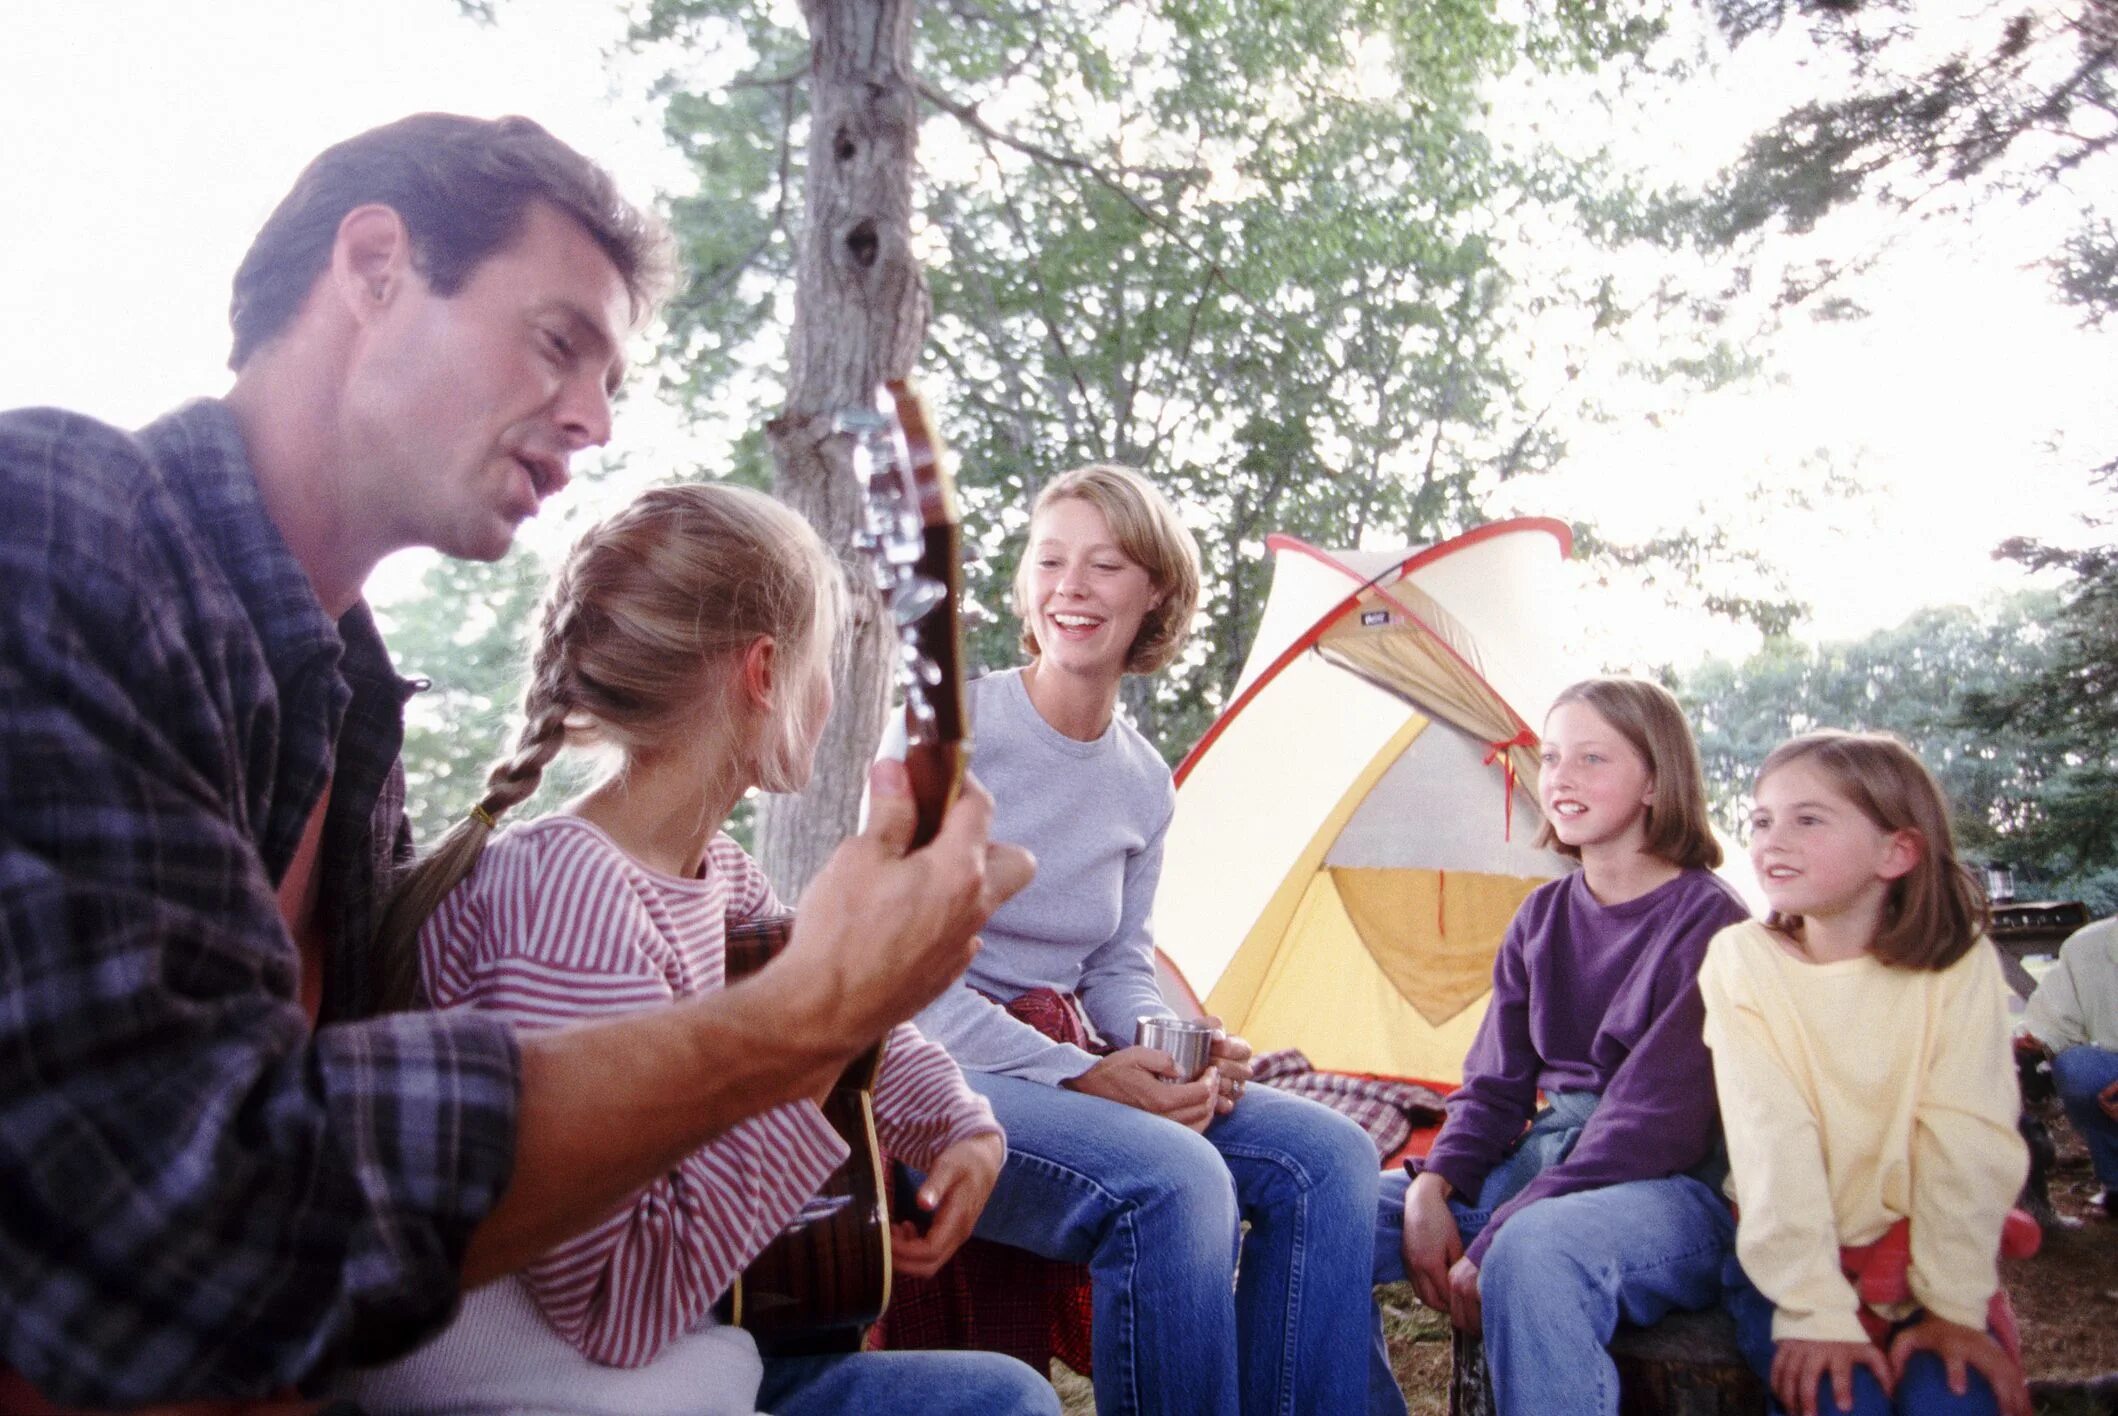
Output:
(1680, 591), (2118, 912)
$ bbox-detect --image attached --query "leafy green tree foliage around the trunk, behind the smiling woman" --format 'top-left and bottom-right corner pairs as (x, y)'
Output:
(635, 0), (1790, 756)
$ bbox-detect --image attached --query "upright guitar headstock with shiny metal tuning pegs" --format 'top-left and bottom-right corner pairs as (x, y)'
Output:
(834, 379), (966, 845)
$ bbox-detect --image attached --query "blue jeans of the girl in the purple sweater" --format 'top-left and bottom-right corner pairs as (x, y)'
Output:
(1368, 1092), (1735, 1416)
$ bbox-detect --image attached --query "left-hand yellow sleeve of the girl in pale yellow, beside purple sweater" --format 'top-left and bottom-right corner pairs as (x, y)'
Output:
(1699, 936), (1868, 1344)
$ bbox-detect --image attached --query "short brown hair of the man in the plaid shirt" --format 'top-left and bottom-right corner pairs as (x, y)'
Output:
(229, 112), (669, 370)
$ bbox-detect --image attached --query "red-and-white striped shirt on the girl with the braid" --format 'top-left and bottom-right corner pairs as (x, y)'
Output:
(419, 817), (1000, 1367)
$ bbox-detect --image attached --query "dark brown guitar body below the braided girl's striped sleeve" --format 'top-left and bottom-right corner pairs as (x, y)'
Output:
(722, 914), (890, 1357)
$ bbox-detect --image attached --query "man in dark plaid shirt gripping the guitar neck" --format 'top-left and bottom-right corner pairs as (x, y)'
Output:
(0, 114), (1031, 1412)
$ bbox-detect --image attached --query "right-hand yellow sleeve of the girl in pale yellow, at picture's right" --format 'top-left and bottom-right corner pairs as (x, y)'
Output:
(1910, 940), (2029, 1331)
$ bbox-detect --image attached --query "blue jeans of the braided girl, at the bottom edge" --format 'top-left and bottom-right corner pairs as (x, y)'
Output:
(758, 1353), (1059, 1416)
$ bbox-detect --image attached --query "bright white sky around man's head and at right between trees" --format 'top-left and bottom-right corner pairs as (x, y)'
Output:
(0, 0), (2118, 665)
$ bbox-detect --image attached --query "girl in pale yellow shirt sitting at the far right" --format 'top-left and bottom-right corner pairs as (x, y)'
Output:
(1699, 732), (2029, 1416)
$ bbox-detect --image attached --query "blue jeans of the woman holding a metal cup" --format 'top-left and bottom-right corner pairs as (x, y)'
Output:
(966, 1071), (1377, 1416)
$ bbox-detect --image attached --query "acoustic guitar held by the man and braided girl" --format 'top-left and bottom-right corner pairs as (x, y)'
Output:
(722, 381), (968, 1357)
